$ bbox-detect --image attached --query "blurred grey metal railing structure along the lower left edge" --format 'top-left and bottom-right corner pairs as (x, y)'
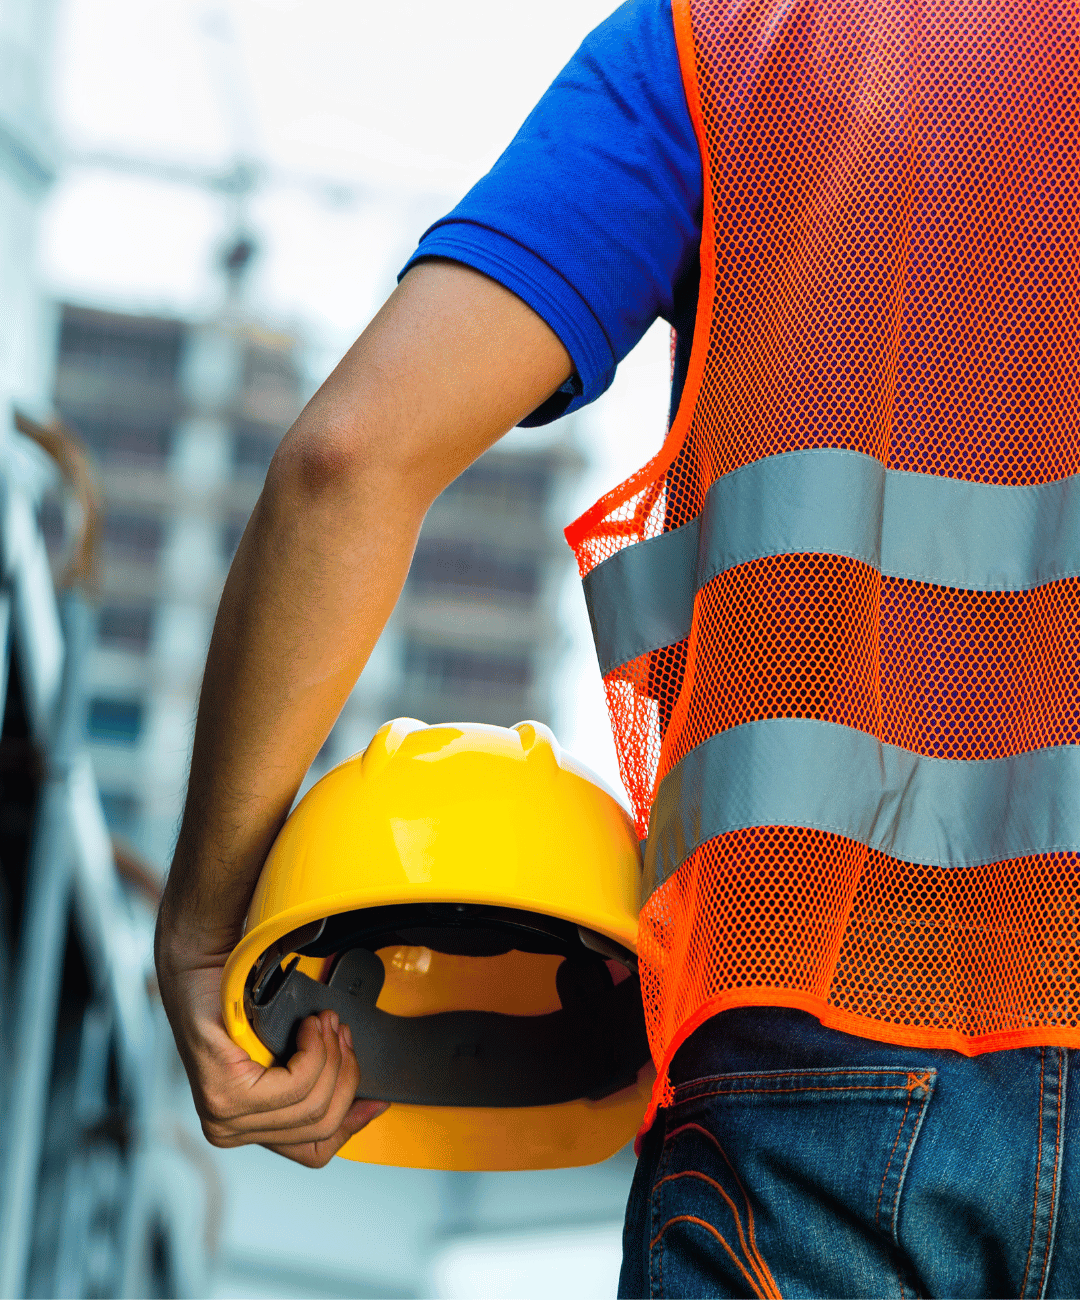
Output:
(0, 419), (214, 1296)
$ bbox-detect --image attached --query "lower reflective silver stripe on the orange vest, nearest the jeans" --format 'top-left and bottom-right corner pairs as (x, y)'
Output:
(645, 718), (1080, 892)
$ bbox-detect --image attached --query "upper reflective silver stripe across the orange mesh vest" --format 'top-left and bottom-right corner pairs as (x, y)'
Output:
(585, 450), (1080, 672)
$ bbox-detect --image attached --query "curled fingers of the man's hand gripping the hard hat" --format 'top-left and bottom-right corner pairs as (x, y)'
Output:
(203, 1011), (369, 1147)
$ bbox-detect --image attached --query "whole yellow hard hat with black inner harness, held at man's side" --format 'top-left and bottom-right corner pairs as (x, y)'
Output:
(222, 718), (652, 1170)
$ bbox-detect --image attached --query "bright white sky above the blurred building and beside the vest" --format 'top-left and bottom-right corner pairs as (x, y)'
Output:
(43, 0), (668, 780)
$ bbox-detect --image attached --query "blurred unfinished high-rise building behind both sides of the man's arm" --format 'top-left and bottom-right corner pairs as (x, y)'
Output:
(45, 297), (582, 866)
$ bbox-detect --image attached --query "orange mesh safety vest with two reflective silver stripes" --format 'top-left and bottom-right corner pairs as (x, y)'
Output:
(567, 0), (1080, 1123)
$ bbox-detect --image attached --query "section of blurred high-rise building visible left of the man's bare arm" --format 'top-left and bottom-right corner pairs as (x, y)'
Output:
(47, 306), (303, 866)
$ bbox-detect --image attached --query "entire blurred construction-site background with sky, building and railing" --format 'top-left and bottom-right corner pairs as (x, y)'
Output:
(0, 0), (668, 1297)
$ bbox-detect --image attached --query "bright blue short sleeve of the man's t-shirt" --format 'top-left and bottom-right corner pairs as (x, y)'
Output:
(402, 0), (702, 425)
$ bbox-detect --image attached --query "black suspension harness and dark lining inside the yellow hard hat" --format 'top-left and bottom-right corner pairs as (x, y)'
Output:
(244, 904), (649, 1106)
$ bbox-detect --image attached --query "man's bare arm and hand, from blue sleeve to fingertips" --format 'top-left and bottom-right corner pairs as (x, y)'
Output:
(157, 263), (572, 1164)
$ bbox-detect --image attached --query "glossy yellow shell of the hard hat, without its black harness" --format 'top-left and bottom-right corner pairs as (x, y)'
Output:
(222, 718), (651, 1170)
